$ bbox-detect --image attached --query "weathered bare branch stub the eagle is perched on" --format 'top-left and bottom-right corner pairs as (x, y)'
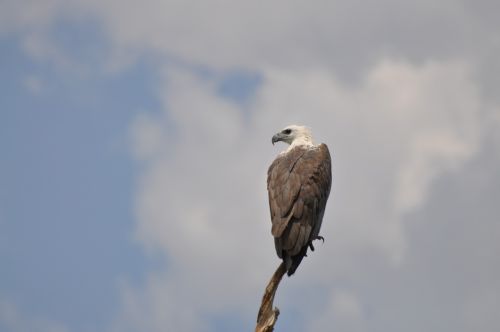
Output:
(255, 262), (286, 332)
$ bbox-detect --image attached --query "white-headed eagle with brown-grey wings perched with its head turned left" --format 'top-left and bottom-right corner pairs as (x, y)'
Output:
(267, 125), (332, 276)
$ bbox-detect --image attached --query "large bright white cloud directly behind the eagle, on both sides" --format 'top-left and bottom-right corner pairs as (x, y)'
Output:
(118, 61), (488, 331)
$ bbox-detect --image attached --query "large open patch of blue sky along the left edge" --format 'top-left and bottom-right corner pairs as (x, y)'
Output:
(0, 33), (155, 330)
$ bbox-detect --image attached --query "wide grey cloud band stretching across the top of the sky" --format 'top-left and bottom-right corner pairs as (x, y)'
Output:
(0, 0), (499, 77)
